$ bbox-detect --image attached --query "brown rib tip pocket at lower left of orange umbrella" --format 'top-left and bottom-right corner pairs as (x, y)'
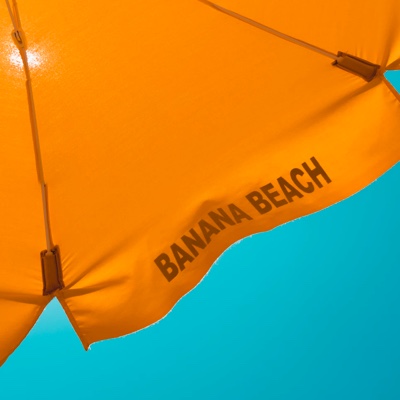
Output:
(40, 246), (64, 296)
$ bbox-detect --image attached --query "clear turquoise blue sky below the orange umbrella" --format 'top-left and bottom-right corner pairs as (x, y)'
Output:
(0, 73), (400, 400)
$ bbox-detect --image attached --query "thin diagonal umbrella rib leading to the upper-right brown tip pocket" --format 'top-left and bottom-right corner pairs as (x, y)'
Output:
(199, 0), (339, 61)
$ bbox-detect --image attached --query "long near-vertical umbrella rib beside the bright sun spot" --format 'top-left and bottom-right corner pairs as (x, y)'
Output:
(6, 0), (53, 252)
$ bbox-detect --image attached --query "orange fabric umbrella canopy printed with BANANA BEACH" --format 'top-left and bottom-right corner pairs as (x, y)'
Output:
(0, 0), (400, 362)
